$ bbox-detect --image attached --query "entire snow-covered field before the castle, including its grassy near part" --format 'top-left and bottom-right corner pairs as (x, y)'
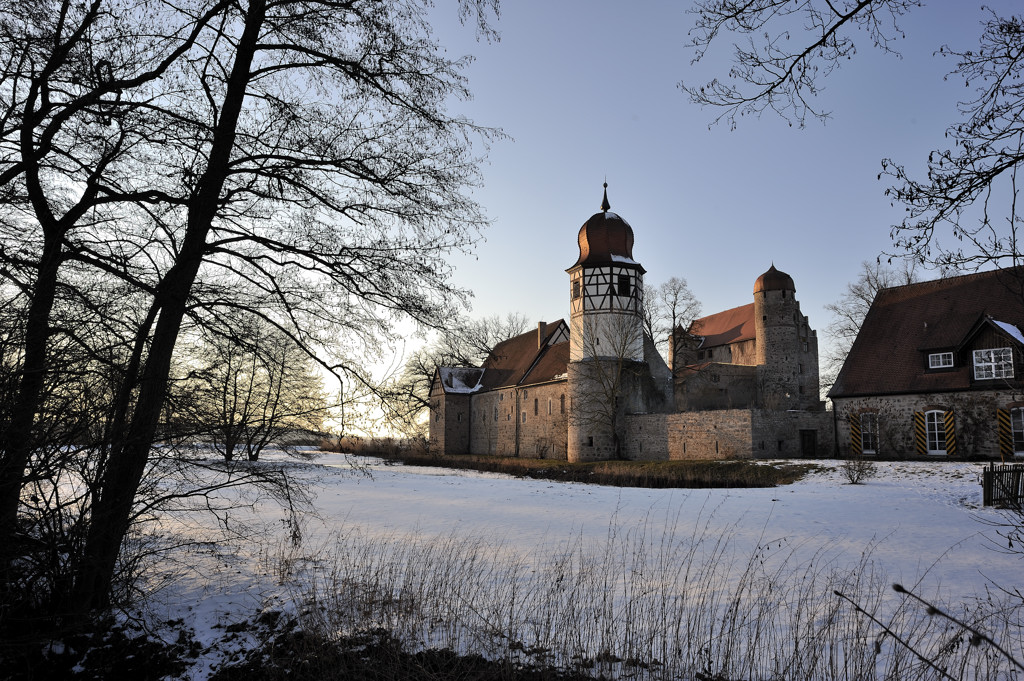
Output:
(151, 455), (1021, 679)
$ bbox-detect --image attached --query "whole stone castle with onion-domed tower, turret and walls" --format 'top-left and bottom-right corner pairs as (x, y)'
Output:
(430, 184), (835, 461)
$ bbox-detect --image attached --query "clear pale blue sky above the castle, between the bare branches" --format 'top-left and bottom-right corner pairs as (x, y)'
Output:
(413, 0), (1017, 360)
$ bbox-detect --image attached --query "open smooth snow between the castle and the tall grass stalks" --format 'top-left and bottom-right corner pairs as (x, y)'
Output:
(142, 455), (1021, 679)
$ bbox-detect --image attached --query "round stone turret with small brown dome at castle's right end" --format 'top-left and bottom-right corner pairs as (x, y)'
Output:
(754, 264), (819, 410)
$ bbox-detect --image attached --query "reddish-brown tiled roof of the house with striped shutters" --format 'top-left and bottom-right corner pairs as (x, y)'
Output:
(828, 267), (1024, 397)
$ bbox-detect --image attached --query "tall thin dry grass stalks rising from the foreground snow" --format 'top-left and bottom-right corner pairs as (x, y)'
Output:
(232, 517), (1024, 681)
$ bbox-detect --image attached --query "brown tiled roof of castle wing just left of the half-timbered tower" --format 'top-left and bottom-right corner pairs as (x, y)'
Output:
(480, 320), (568, 390)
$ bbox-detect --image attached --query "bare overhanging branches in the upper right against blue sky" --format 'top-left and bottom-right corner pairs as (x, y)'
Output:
(680, 0), (1024, 269)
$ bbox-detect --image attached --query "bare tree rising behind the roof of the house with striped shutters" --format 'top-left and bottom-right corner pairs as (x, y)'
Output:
(820, 259), (920, 392)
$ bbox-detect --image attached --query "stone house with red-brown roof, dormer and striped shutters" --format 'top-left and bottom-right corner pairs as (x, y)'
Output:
(828, 267), (1024, 459)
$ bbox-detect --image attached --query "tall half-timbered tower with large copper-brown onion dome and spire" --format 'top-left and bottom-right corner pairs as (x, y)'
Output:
(566, 182), (645, 461)
